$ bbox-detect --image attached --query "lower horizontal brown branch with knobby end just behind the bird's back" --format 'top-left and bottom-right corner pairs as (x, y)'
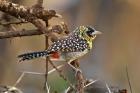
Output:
(0, 25), (62, 39)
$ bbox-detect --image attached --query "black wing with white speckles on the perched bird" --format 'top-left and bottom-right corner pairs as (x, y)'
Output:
(47, 36), (89, 53)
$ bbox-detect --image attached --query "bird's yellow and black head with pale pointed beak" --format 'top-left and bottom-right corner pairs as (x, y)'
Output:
(79, 26), (102, 40)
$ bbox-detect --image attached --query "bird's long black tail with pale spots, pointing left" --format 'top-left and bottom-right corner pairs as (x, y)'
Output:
(18, 51), (49, 62)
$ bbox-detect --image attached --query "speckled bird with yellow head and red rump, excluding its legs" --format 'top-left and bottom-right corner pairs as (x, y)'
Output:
(18, 26), (101, 63)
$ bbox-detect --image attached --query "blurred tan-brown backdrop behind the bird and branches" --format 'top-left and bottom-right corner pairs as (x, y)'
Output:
(0, 0), (140, 93)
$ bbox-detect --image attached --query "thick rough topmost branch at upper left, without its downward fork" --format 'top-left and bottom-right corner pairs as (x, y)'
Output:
(0, 0), (57, 23)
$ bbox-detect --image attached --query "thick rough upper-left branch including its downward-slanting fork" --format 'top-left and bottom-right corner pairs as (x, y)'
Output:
(0, 0), (60, 33)
